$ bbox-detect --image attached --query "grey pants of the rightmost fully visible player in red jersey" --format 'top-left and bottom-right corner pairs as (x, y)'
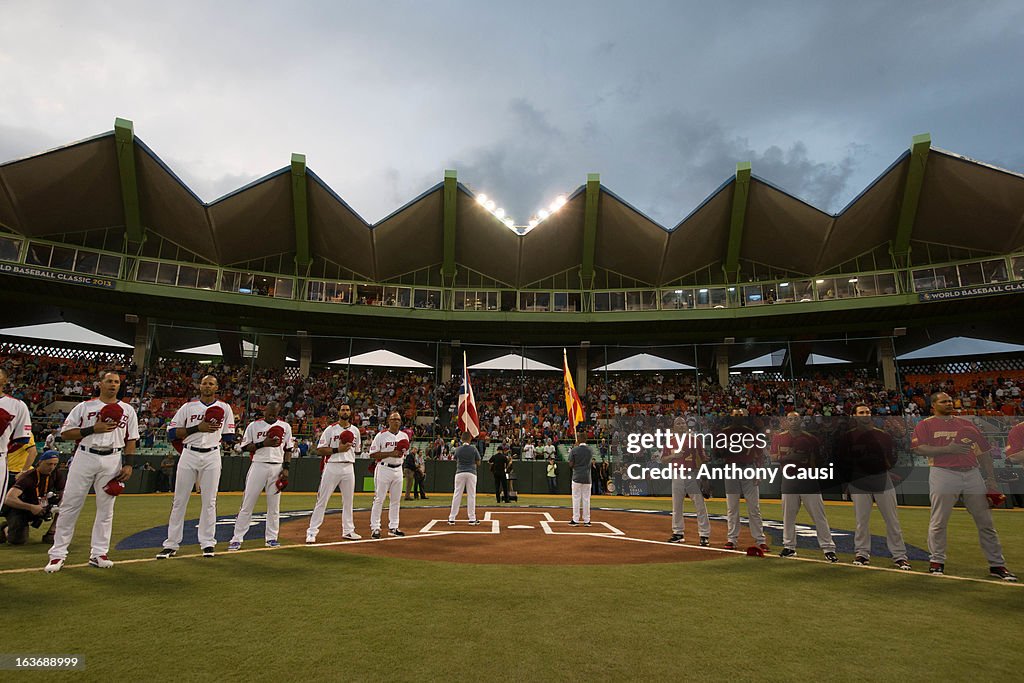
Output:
(925, 467), (1006, 567)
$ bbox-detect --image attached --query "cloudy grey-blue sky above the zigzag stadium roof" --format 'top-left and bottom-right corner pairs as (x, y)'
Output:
(0, 0), (1024, 227)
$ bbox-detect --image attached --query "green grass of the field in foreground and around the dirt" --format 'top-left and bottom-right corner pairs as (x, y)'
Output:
(0, 494), (1024, 681)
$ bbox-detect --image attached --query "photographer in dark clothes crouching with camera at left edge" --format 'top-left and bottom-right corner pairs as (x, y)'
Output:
(0, 451), (65, 546)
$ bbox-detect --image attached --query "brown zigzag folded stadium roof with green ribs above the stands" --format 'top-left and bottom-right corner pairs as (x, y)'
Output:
(0, 124), (1024, 289)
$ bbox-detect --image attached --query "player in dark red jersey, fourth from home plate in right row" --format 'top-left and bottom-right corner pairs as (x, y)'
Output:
(837, 403), (910, 571)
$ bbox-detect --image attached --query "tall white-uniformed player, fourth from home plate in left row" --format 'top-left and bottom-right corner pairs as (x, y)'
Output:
(157, 375), (234, 560)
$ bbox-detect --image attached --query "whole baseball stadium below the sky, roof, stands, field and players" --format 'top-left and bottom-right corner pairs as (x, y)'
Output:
(0, 119), (1024, 680)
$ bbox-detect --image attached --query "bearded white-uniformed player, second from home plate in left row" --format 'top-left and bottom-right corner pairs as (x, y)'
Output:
(306, 403), (362, 543)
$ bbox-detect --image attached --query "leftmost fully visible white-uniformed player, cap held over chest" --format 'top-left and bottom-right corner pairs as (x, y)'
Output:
(44, 371), (138, 573)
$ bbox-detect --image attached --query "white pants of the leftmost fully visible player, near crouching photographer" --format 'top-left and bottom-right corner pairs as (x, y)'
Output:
(49, 449), (121, 559)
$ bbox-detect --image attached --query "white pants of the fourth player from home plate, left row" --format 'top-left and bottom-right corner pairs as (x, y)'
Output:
(164, 446), (221, 550)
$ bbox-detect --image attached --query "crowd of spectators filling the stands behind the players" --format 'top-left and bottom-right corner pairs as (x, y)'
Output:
(0, 348), (1024, 458)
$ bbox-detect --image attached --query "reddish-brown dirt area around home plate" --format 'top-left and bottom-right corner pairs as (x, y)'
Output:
(281, 507), (753, 564)
